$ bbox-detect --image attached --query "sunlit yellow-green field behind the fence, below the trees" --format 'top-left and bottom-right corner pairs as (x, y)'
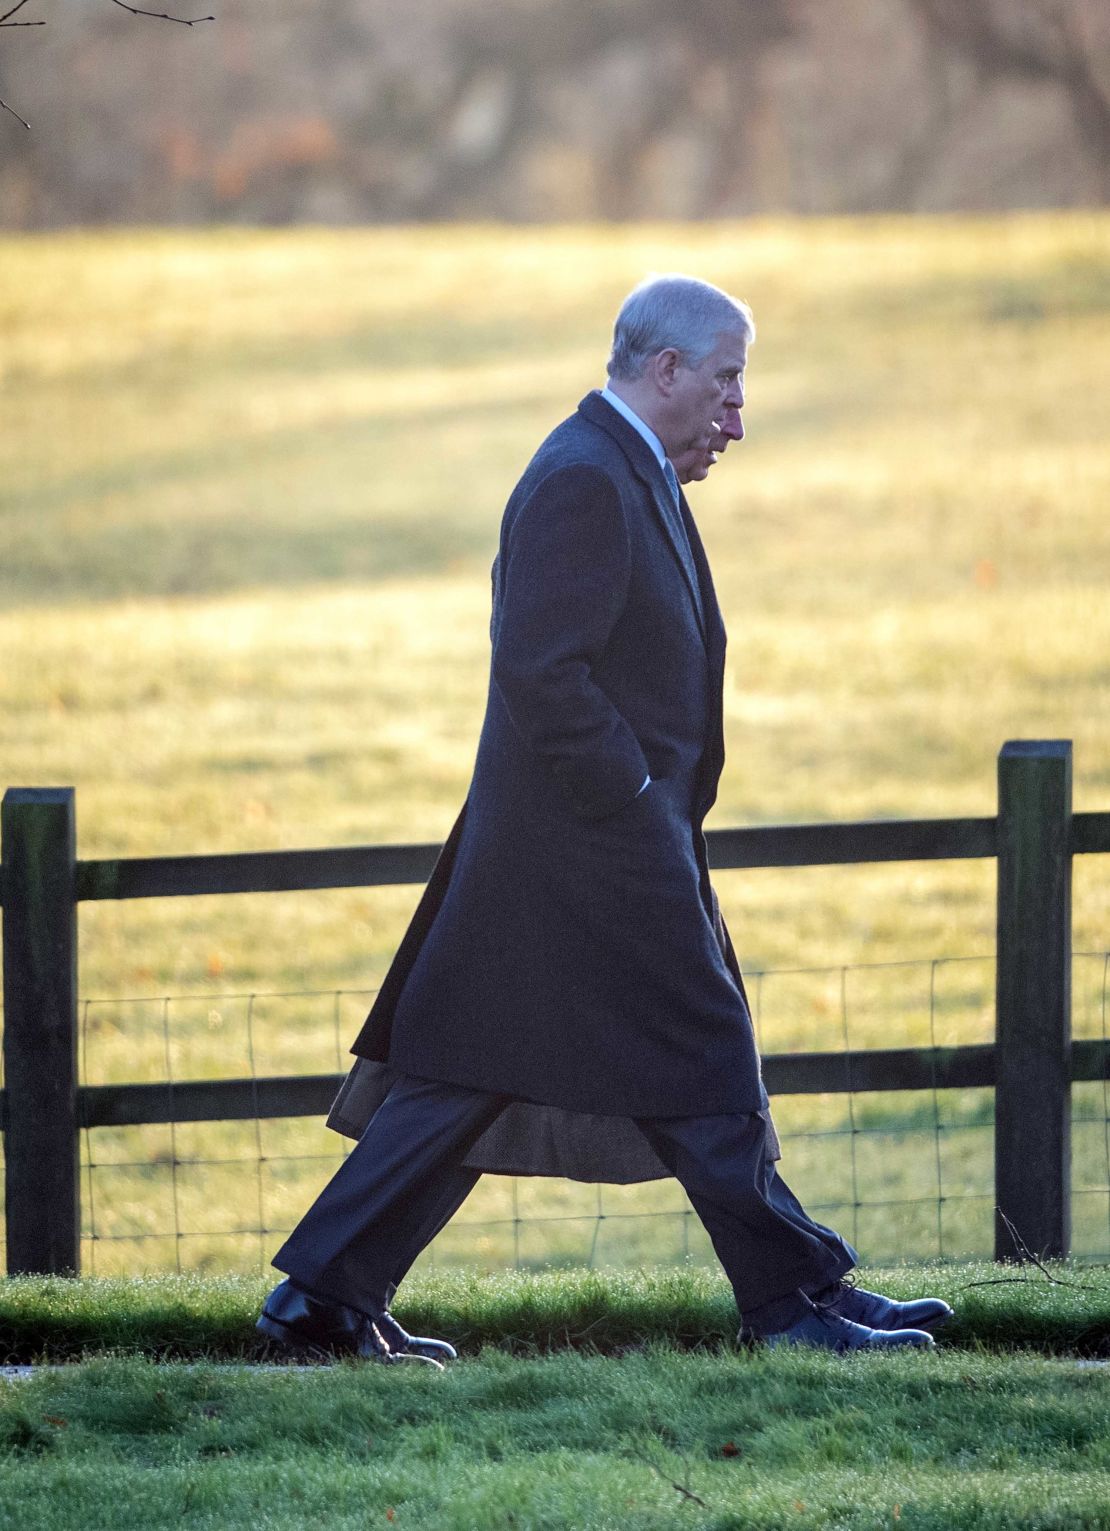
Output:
(0, 214), (1110, 1271)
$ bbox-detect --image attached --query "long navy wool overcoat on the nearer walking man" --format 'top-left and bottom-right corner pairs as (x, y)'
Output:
(331, 393), (767, 1180)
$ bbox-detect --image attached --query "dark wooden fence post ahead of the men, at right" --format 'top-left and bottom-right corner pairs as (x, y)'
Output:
(995, 739), (1072, 1260)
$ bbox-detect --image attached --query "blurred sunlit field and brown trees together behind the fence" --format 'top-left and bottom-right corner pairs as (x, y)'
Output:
(0, 0), (1110, 1271)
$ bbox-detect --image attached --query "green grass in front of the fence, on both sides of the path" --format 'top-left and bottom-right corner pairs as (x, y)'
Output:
(0, 1266), (1110, 1531)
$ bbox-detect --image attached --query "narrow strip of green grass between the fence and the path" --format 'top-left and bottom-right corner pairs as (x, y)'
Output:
(0, 1262), (1110, 1364)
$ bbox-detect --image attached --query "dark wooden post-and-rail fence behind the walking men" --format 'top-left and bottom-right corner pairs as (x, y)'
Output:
(0, 739), (1110, 1274)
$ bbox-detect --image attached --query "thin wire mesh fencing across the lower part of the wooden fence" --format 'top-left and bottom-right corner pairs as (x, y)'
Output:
(53, 952), (1110, 1274)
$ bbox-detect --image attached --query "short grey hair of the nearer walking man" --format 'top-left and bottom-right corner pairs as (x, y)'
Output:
(608, 273), (755, 383)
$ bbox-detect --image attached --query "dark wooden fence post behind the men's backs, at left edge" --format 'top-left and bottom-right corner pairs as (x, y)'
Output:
(0, 787), (81, 1275)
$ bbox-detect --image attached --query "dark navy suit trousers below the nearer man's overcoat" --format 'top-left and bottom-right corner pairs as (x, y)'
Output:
(274, 1076), (856, 1332)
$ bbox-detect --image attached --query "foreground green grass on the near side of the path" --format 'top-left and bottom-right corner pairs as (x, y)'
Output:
(0, 1347), (1110, 1531)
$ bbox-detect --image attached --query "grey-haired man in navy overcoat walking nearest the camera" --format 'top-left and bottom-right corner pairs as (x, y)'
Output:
(259, 276), (948, 1364)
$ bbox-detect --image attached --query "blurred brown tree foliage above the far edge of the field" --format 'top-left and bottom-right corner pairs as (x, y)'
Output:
(0, 0), (1110, 227)
